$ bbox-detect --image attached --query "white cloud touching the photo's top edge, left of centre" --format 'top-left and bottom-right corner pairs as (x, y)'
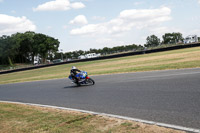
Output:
(33, 0), (85, 11)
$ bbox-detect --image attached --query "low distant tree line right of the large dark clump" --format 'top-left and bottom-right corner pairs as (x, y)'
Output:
(60, 32), (186, 59)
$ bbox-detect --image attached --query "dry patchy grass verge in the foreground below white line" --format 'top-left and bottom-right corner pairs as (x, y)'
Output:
(0, 103), (186, 133)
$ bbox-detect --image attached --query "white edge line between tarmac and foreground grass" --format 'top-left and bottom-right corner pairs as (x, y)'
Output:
(0, 100), (200, 133)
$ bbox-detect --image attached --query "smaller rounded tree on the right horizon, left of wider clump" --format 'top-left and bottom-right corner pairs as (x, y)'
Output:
(144, 35), (160, 47)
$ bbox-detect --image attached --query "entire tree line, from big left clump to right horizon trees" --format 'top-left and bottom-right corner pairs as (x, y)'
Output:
(0, 31), (200, 64)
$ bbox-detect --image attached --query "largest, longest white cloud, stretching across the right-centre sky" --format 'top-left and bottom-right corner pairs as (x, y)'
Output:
(70, 7), (171, 35)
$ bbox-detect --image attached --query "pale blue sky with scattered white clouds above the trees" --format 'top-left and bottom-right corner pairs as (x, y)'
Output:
(0, 0), (200, 52)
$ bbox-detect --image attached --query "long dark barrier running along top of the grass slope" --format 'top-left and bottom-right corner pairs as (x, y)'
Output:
(0, 43), (200, 74)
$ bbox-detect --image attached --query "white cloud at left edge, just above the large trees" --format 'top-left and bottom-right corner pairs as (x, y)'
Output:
(0, 14), (36, 35)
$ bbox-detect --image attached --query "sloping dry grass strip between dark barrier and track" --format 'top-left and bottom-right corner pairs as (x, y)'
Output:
(0, 47), (200, 84)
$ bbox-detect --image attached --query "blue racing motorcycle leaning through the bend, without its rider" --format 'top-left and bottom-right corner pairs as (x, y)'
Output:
(69, 71), (95, 86)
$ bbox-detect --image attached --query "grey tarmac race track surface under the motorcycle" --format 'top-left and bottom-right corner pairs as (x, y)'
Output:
(0, 68), (200, 129)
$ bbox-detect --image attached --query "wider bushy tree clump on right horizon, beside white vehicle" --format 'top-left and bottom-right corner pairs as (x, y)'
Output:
(162, 32), (183, 44)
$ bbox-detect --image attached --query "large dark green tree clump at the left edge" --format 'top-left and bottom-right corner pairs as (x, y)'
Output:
(0, 31), (60, 65)
